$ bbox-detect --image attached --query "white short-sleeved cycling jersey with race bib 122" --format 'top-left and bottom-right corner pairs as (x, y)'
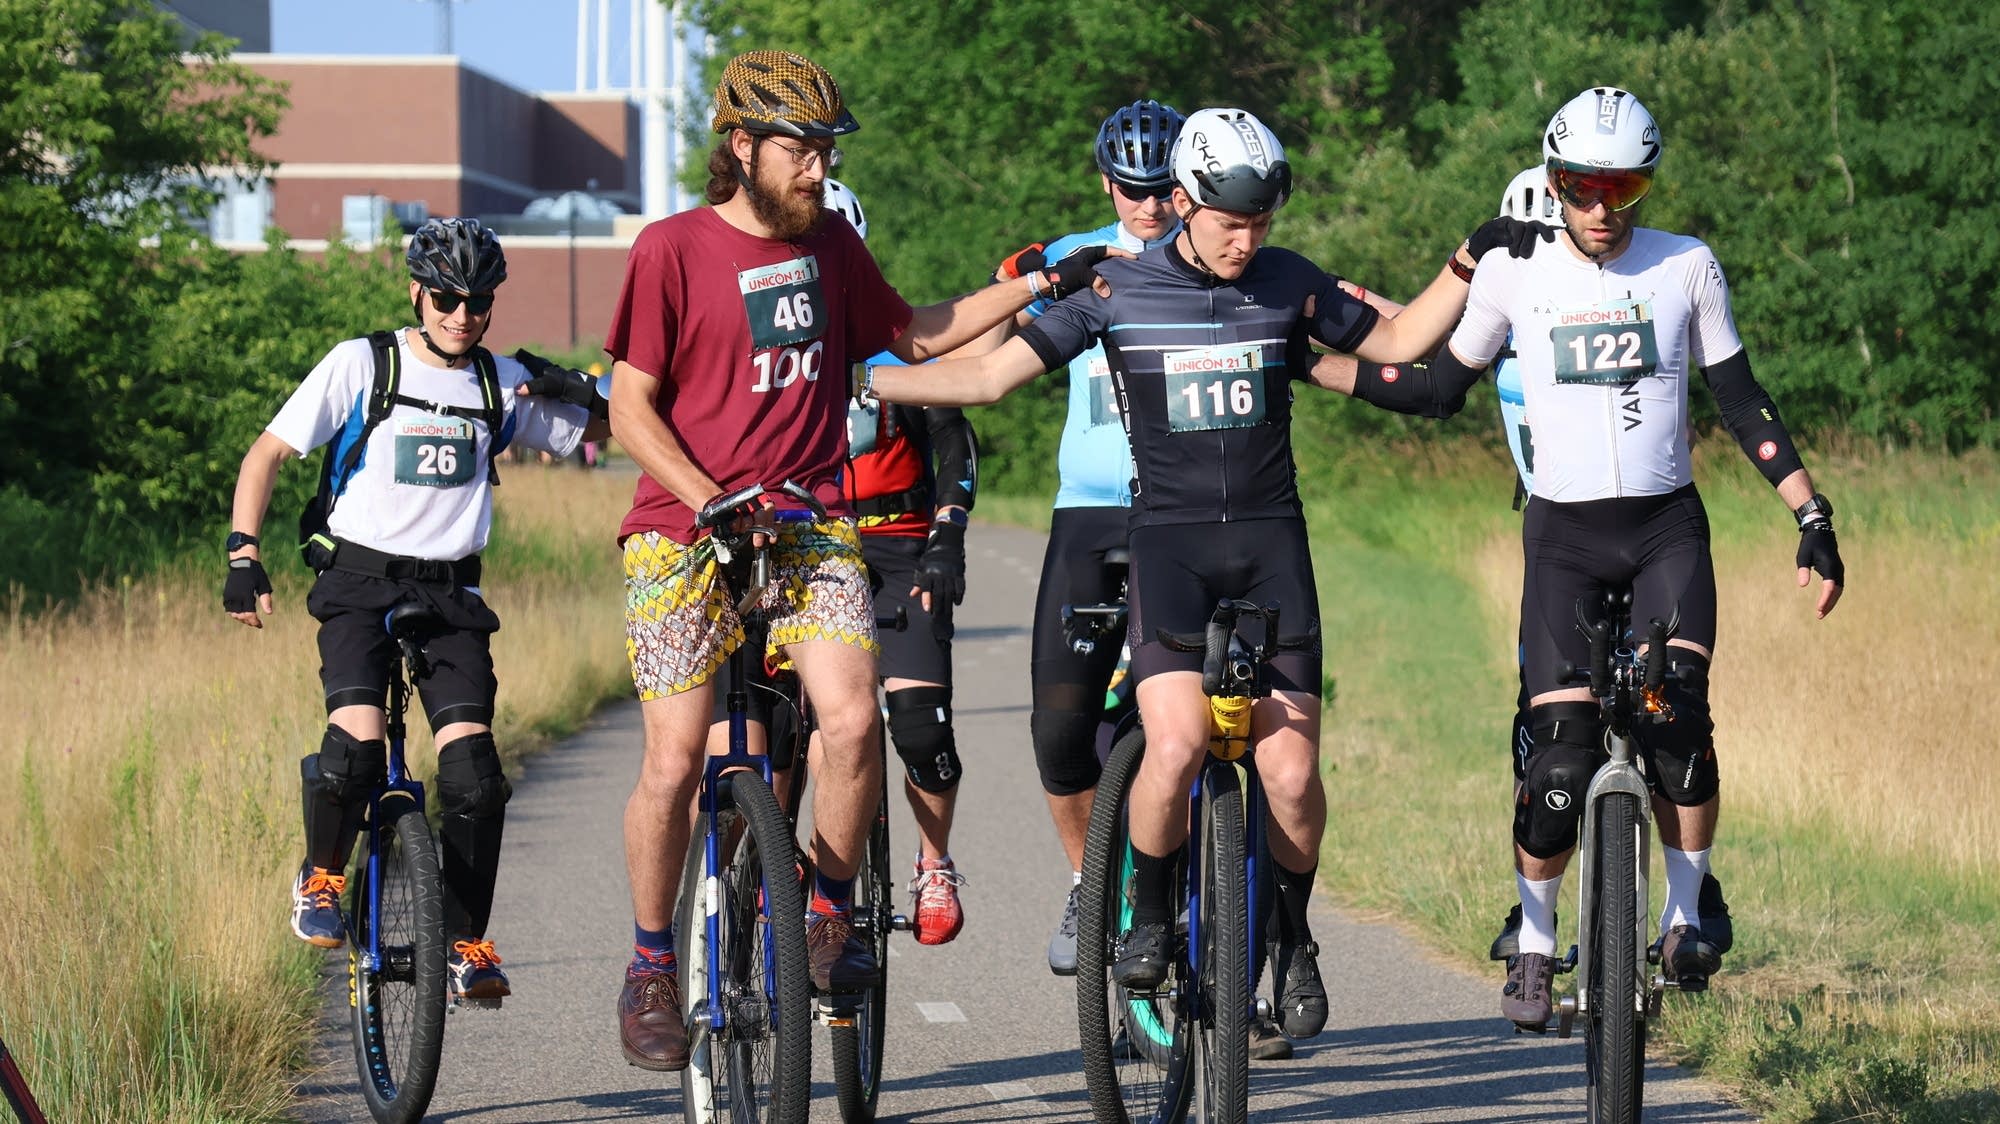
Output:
(1452, 228), (1742, 502)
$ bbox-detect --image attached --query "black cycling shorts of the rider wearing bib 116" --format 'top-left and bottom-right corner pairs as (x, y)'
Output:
(1126, 518), (1320, 698)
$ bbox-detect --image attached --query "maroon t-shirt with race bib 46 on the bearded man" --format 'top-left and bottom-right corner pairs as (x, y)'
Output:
(604, 206), (912, 542)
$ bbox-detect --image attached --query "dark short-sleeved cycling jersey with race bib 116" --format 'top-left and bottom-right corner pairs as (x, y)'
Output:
(1020, 244), (1378, 528)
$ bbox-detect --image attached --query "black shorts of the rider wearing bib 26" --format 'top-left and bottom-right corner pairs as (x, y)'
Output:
(306, 570), (500, 730)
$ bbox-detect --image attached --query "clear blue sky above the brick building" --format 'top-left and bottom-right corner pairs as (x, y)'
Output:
(270, 0), (646, 90)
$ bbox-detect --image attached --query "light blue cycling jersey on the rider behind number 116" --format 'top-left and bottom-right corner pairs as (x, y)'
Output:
(1028, 222), (1180, 508)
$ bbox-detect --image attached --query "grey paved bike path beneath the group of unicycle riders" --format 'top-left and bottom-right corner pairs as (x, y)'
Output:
(298, 526), (1750, 1124)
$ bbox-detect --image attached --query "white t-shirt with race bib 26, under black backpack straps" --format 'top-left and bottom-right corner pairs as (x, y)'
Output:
(266, 328), (590, 560)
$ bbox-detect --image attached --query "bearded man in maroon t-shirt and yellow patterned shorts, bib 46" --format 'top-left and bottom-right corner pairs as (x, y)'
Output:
(604, 50), (1102, 1070)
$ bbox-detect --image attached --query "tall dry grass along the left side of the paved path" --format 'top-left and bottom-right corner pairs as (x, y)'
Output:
(0, 466), (630, 1122)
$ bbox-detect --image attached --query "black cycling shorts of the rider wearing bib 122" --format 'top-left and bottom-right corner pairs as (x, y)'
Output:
(1520, 484), (1716, 698)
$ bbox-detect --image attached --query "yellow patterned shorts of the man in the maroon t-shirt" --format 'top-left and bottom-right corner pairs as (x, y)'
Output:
(624, 520), (880, 698)
